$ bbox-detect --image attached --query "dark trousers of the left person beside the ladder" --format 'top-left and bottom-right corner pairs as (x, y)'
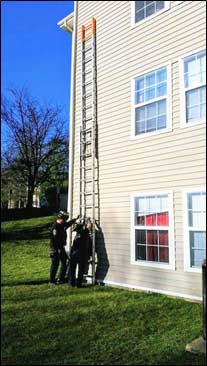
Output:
(50, 248), (67, 282)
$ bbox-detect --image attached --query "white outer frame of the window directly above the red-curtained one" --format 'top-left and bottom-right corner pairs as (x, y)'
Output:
(131, 62), (172, 140)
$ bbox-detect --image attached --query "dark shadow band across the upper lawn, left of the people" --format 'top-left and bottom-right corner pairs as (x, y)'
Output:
(1, 223), (51, 241)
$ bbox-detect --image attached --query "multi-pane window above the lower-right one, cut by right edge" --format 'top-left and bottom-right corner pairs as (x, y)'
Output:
(181, 51), (206, 127)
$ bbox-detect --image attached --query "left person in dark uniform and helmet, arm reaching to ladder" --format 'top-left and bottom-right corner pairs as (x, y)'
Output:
(49, 211), (79, 284)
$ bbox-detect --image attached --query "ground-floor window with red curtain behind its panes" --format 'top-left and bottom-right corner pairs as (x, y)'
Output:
(132, 194), (173, 267)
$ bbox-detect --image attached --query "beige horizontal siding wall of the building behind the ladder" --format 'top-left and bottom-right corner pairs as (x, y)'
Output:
(73, 1), (205, 297)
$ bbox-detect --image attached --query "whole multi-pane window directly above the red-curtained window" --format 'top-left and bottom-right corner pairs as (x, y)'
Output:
(133, 66), (169, 136)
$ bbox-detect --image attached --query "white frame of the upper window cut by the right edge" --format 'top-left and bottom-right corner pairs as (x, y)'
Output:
(178, 47), (206, 128)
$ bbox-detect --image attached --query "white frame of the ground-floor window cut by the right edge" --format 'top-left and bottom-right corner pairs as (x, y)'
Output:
(183, 187), (206, 273)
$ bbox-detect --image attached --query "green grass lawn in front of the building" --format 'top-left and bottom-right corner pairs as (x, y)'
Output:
(1, 217), (205, 365)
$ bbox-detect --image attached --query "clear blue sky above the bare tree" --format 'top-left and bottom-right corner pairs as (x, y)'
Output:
(1, 0), (73, 151)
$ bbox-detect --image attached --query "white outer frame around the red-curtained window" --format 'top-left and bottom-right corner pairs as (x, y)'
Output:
(131, 190), (175, 271)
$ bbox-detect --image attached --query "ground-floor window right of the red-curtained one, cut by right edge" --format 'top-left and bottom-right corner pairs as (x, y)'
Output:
(185, 191), (206, 269)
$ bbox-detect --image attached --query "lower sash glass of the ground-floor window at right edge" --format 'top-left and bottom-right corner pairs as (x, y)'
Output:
(189, 231), (206, 267)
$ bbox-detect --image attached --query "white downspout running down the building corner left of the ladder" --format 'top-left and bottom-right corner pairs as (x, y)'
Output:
(67, 1), (78, 251)
